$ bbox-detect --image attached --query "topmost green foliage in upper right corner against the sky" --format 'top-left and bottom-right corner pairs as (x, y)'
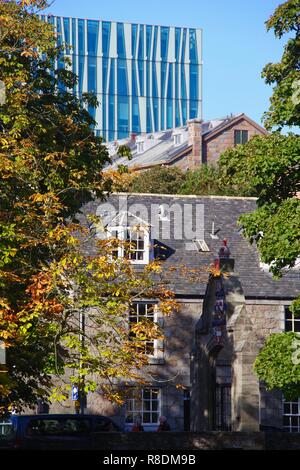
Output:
(262, 0), (300, 129)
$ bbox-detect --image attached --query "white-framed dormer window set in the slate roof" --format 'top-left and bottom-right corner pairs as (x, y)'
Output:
(108, 226), (150, 264)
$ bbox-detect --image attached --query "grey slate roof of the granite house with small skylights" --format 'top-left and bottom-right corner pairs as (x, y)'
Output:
(82, 194), (300, 300)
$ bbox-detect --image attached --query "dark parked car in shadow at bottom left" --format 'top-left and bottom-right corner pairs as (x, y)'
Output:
(0, 414), (121, 450)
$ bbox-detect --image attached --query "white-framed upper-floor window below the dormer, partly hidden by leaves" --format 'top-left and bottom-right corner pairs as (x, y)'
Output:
(129, 302), (158, 357)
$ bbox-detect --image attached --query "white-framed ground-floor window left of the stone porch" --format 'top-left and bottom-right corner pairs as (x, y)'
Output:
(125, 387), (161, 427)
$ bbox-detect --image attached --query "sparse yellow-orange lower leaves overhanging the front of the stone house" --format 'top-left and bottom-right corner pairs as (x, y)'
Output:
(23, 228), (177, 408)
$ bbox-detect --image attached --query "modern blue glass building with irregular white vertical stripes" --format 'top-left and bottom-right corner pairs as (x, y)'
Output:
(42, 16), (202, 141)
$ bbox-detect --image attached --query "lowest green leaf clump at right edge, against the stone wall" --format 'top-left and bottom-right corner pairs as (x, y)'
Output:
(254, 332), (300, 400)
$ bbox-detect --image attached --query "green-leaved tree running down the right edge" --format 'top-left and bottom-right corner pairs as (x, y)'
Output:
(220, 0), (300, 399)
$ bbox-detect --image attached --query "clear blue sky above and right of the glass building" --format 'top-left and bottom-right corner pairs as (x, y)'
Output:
(47, 0), (286, 123)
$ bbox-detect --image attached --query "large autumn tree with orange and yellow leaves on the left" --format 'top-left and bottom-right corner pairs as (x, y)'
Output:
(0, 0), (179, 411)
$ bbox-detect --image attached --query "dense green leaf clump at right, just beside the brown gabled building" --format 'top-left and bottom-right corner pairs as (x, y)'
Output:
(219, 133), (300, 206)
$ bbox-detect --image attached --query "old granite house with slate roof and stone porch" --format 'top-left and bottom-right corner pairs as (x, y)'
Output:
(51, 194), (300, 432)
